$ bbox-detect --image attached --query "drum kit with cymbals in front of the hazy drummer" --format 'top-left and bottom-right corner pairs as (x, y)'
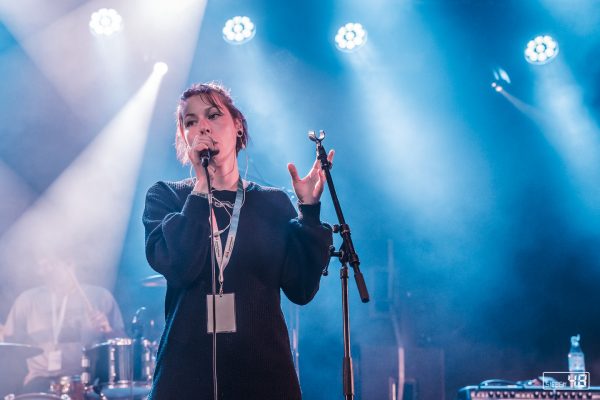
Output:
(0, 275), (166, 400)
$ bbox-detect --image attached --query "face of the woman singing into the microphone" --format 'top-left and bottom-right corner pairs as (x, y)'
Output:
(180, 96), (242, 166)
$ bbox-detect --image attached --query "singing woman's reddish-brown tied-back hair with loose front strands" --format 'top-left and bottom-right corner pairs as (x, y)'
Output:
(175, 82), (249, 165)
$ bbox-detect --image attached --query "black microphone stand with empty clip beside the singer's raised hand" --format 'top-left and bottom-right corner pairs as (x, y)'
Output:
(308, 131), (369, 400)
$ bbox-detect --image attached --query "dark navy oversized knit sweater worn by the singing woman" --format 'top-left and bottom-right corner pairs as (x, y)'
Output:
(143, 179), (332, 400)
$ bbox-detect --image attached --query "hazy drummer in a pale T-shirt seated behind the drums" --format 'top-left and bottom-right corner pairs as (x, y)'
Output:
(3, 259), (124, 393)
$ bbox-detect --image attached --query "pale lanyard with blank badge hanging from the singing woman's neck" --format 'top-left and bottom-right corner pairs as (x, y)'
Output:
(206, 178), (244, 333)
